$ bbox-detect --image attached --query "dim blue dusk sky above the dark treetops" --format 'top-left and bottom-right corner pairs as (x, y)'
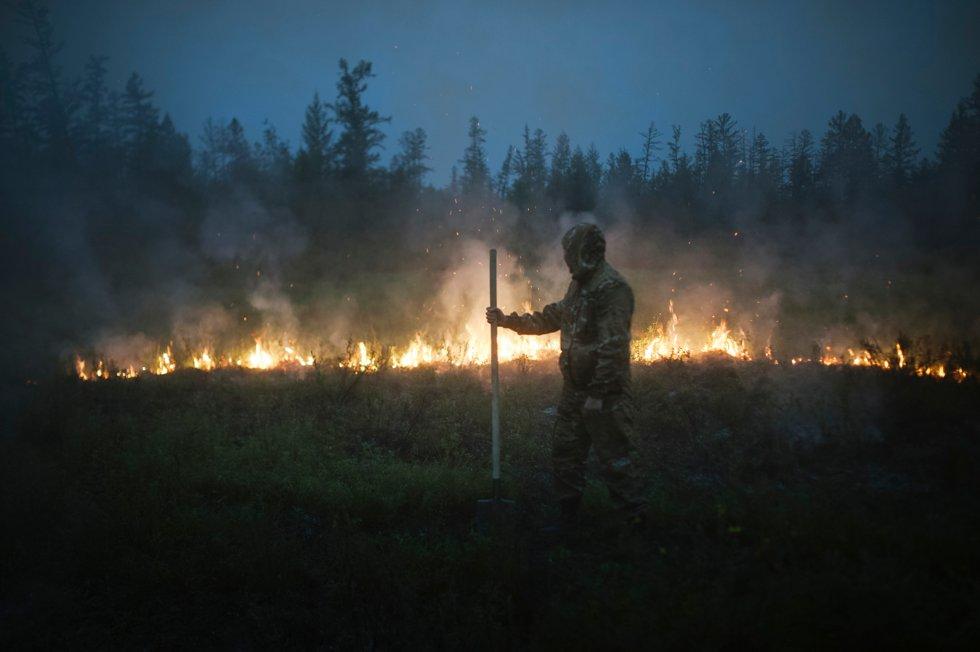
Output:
(2, 0), (980, 184)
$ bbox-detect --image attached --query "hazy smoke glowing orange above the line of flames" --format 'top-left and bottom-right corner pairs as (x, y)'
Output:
(1, 166), (980, 384)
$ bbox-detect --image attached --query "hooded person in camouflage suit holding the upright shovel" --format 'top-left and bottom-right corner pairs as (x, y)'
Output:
(487, 224), (644, 525)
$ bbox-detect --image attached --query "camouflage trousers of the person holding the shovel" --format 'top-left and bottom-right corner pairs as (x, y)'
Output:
(552, 383), (644, 513)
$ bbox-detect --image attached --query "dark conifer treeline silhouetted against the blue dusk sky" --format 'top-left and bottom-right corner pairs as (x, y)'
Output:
(0, 1), (980, 250)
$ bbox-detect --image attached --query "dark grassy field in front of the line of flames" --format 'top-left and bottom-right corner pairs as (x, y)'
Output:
(0, 359), (980, 649)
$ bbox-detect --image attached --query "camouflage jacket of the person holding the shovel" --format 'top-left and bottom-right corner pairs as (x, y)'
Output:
(501, 262), (633, 398)
